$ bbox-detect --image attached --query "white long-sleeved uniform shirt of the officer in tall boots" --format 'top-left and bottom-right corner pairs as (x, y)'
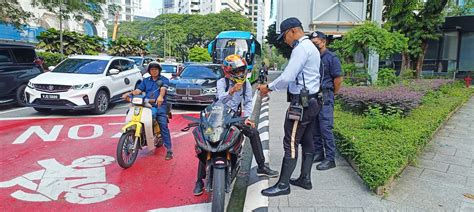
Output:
(268, 36), (321, 94)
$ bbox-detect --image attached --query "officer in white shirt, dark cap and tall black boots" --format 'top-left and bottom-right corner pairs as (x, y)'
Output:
(258, 18), (321, 196)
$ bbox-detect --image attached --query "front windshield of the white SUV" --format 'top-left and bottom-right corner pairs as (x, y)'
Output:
(52, 58), (109, 74)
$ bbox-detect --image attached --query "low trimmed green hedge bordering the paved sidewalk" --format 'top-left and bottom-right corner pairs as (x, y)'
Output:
(334, 82), (474, 190)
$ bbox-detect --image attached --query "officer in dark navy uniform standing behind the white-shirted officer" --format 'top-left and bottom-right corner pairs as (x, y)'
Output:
(310, 31), (343, 170)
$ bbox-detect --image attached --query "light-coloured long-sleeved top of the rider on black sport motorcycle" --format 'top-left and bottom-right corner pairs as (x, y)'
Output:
(217, 78), (252, 117)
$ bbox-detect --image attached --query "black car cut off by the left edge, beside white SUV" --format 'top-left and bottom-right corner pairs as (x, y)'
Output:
(0, 44), (43, 105)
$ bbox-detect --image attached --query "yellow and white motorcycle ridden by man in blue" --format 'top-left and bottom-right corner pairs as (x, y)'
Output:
(117, 83), (163, 169)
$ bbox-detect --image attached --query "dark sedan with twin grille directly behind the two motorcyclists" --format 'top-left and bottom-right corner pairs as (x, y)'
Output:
(168, 64), (224, 105)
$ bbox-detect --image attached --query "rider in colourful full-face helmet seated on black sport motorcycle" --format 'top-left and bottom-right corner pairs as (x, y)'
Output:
(194, 54), (278, 196)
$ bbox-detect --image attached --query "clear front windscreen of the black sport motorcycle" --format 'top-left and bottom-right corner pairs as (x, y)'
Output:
(201, 102), (233, 143)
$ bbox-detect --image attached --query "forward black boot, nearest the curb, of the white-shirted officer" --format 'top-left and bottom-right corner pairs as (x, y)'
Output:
(262, 157), (296, 197)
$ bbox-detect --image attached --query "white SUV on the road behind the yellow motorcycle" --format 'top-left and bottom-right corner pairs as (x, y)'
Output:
(25, 56), (143, 114)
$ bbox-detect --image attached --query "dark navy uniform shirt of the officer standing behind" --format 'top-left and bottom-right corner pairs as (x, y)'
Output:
(321, 49), (342, 91)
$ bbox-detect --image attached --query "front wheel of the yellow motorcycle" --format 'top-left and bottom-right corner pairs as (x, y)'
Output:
(117, 130), (139, 169)
